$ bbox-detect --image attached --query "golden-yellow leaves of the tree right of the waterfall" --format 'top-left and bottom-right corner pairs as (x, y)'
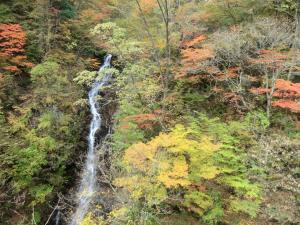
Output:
(115, 125), (220, 202)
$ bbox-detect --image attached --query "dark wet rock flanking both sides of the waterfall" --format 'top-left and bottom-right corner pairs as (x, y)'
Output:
(48, 91), (117, 225)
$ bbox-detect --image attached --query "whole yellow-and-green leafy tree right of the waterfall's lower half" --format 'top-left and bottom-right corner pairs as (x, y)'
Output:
(115, 115), (260, 224)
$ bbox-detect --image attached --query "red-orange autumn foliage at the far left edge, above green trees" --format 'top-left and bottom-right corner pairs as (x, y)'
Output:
(0, 23), (33, 73)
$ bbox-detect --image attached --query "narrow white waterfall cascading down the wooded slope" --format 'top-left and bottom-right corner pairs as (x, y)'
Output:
(70, 55), (112, 225)
